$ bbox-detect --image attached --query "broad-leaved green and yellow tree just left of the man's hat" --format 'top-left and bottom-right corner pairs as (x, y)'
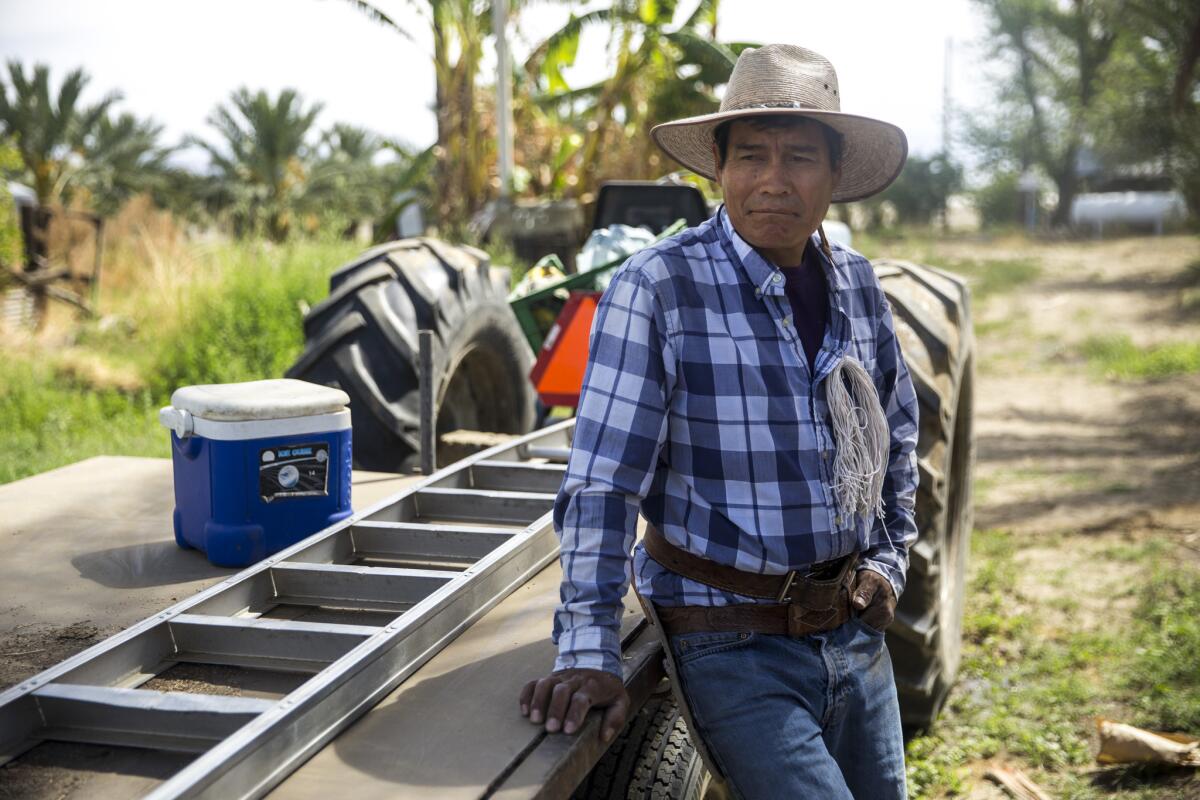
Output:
(526, 0), (751, 193)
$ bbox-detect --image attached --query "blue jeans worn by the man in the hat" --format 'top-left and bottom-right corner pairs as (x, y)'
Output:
(671, 616), (906, 800)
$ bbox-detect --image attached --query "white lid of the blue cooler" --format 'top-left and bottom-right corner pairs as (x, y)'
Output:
(170, 378), (350, 422)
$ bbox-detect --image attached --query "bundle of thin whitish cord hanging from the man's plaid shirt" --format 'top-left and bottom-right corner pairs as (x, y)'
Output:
(826, 355), (890, 519)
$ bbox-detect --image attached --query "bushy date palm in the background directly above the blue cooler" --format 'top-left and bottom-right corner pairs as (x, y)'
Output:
(190, 86), (322, 241)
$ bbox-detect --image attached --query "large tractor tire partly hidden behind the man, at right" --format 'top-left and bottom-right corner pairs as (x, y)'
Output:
(875, 260), (974, 729)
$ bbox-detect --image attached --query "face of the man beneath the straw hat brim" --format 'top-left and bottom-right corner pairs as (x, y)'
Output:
(713, 120), (841, 266)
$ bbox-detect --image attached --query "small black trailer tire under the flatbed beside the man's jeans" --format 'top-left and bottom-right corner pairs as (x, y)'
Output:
(571, 693), (709, 800)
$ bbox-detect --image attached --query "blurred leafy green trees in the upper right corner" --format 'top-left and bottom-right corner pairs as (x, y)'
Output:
(964, 0), (1200, 227)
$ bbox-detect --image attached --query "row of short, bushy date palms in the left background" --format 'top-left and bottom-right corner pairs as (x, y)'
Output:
(0, 61), (427, 241)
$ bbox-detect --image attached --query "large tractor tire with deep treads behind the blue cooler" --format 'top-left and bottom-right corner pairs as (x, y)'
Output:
(287, 239), (535, 471)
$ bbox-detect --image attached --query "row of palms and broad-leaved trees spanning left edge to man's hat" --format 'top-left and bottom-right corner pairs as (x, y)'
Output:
(0, 0), (748, 240)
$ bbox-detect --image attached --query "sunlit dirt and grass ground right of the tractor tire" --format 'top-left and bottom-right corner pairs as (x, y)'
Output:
(910, 236), (1200, 800)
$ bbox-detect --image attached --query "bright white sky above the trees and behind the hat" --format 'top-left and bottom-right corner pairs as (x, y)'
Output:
(0, 0), (983, 172)
